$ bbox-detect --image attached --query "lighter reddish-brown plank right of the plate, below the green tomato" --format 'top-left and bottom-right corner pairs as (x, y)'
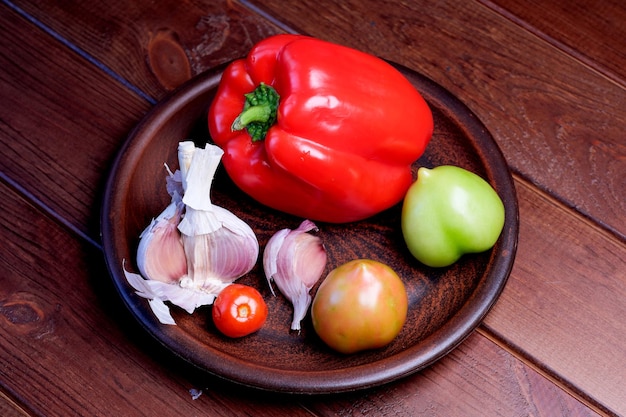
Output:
(485, 176), (626, 415)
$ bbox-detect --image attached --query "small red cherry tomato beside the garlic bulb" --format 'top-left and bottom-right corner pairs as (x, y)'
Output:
(213, 284), (267, 337)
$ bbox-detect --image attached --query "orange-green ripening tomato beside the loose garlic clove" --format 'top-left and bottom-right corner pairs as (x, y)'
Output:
(311, 259), (408, 353)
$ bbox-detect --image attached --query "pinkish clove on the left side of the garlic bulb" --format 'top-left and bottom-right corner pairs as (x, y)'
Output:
(137, 202), (187, 283)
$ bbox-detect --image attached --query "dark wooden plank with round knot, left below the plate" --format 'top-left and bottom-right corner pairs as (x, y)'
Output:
(0, 183), (310, 416)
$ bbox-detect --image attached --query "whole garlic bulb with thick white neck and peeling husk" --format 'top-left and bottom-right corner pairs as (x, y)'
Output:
(124, 141), (259, 324)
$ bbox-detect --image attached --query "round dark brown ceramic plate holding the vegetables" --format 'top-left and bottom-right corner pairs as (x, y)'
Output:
(102, 62), (518, 393)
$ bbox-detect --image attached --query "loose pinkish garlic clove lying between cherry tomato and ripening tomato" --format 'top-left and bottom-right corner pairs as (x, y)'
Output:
(263, 220), (326, 331)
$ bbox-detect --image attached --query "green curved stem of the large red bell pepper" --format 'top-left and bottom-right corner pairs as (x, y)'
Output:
(231, 83), (280, 142)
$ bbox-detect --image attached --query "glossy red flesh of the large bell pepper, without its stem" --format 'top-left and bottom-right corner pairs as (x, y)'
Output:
(208, 35), (433, 223)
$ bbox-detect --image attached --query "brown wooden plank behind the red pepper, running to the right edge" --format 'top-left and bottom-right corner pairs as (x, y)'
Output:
(243, 0), (626, 238)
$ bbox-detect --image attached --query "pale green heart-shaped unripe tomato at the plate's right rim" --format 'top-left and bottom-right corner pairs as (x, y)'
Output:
(402, 165), (504, 267)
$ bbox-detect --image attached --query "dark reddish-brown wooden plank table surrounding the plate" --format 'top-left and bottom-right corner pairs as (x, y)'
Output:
(0, 0), (626, 417)
